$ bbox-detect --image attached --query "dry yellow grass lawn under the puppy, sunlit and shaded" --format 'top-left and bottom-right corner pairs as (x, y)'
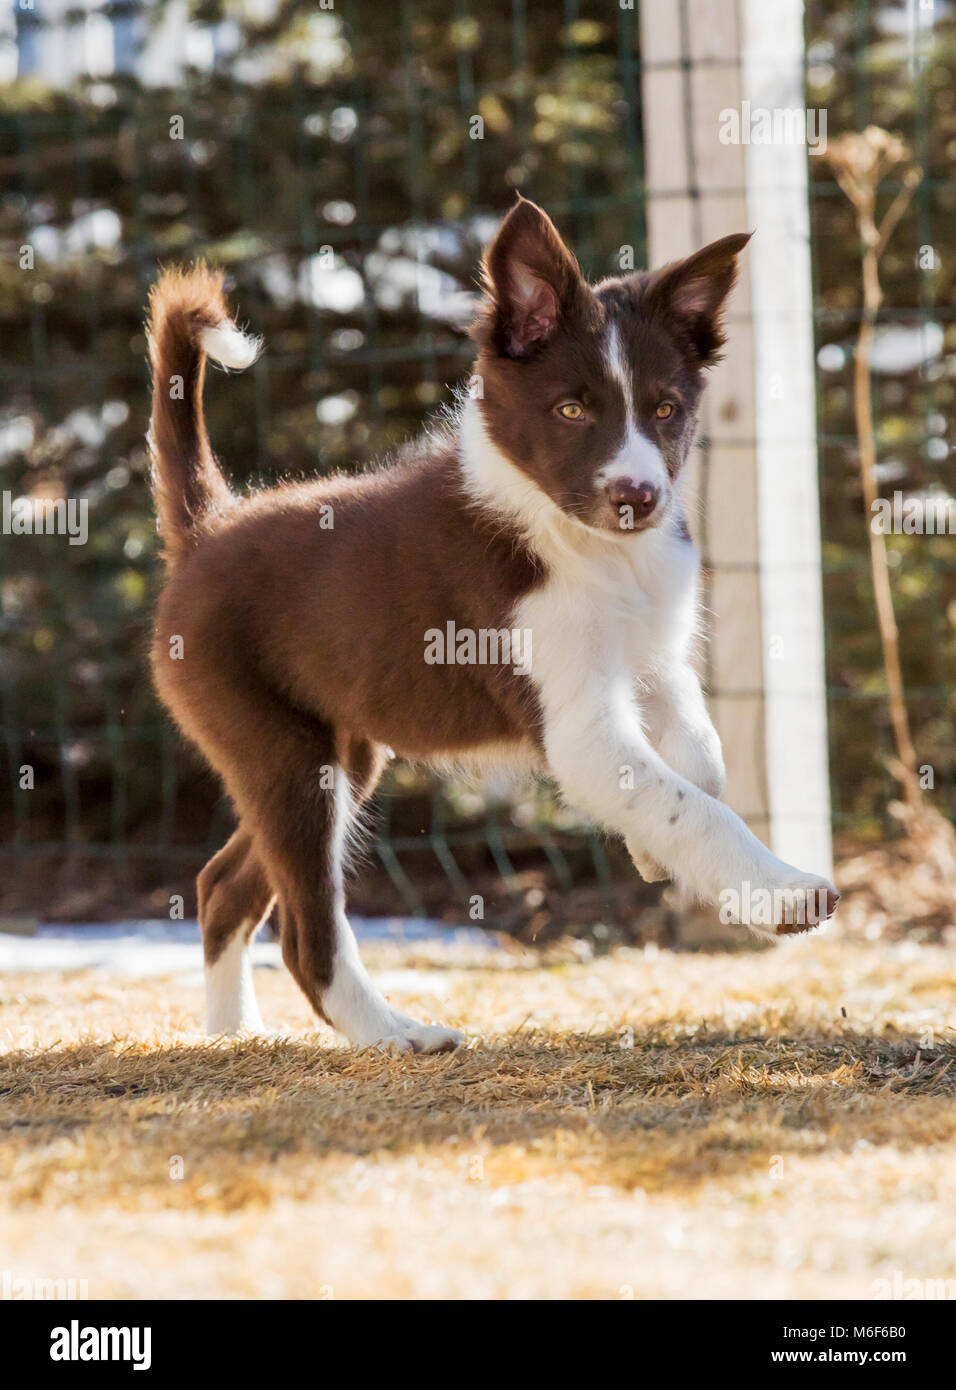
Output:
(0, 940), (956, 1298)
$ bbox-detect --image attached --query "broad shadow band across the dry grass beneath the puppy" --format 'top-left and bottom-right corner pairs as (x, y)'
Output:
(0, 1030), (956, 1205)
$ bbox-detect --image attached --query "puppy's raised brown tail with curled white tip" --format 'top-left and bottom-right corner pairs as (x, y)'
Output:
(146, 263), (261, 562)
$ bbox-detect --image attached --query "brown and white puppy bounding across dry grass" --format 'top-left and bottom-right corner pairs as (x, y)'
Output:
(149, 199), (837, 1051)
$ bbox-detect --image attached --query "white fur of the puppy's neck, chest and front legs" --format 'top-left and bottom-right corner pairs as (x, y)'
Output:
(461, 402), (830, 928)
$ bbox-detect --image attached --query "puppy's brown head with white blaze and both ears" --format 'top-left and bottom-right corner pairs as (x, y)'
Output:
(472, 199), (749, 535)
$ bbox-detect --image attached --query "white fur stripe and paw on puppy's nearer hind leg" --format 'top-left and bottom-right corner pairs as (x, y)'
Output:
(322, 769), (463, 1052)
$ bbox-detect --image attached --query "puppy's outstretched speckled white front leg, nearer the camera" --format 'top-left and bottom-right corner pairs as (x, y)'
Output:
(542, 673), (837, 929)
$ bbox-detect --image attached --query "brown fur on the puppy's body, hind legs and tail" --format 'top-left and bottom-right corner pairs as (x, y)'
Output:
(151, 270), (542, 1012)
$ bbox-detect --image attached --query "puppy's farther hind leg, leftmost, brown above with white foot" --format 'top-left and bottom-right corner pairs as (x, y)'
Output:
(196, 826), (275, 1037)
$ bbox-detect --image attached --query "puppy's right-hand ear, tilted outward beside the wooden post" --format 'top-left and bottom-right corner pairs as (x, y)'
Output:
(642, 232), (753, 366)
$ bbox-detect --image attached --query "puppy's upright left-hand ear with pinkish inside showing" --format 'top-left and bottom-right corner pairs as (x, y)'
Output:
(482, 197), (585, 357)
